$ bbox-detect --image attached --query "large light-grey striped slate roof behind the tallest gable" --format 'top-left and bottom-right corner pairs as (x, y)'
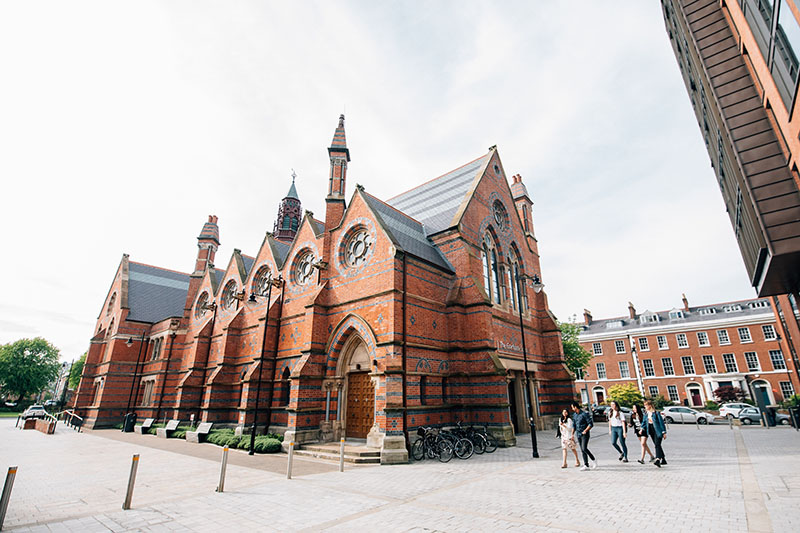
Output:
(386, 152), (492, 235)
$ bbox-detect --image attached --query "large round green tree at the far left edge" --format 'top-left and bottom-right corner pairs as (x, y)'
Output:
(0, 337), (61, 402)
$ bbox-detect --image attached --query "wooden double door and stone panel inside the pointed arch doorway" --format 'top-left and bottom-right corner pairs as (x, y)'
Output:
(337, 335), (375, 439)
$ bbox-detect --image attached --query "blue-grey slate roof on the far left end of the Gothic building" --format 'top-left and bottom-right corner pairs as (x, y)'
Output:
(128, 261), (189, 324)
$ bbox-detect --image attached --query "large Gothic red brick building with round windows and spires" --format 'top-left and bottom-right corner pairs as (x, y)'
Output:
(76, 116), (573, 462)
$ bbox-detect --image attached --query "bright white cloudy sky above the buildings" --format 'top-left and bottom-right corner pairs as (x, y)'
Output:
(0, 0), (755, 360)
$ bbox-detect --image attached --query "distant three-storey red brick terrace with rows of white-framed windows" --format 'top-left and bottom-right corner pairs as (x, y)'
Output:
(575, 296), (800, 407)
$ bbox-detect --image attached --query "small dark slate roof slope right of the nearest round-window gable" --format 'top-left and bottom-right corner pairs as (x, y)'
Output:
(362, 191), (455, 272)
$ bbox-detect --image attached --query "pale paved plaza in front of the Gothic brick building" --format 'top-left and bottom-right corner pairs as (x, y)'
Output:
(0, 419), (800, 533)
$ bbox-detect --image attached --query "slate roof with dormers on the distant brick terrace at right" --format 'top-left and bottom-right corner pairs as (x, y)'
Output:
(581, 298), (773, 335)
